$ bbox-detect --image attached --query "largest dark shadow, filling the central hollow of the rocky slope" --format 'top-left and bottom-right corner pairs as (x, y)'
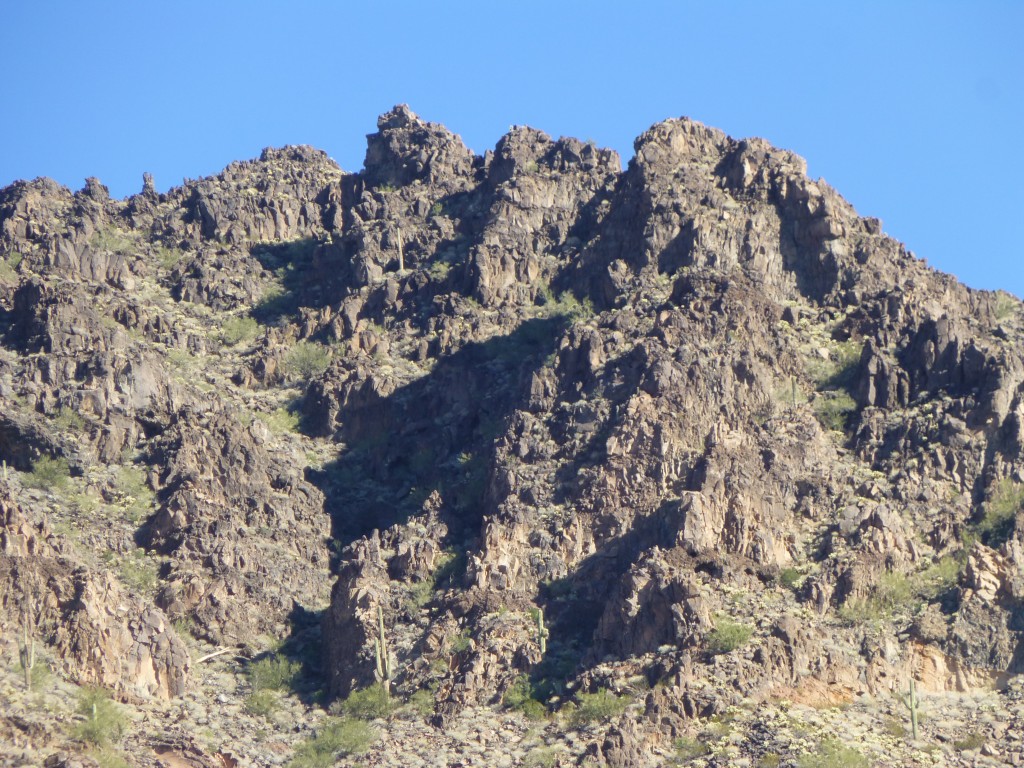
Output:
(309, 317), (567, 549)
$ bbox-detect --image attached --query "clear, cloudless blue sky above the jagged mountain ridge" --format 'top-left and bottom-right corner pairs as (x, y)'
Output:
(0, 0), (1024, 296)
